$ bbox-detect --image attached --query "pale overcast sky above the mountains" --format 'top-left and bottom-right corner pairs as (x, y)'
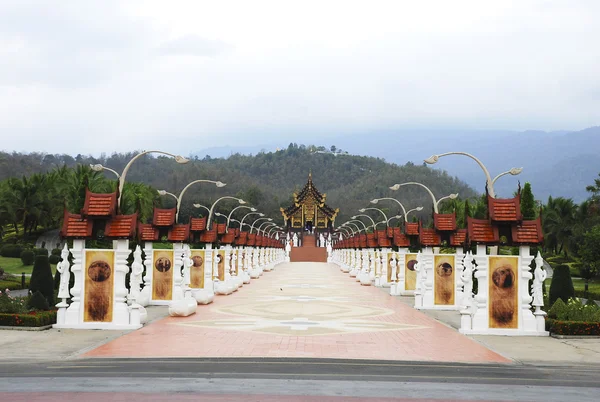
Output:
(0, 0), (600, 154)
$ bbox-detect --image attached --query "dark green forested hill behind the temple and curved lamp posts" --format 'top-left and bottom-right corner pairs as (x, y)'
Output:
(0, 144), (477, 223)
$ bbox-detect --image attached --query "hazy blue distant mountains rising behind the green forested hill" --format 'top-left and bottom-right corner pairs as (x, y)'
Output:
(196, 127), (600, 202)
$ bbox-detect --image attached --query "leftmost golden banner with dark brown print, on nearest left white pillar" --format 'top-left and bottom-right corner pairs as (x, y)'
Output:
(83, 250), (115, 322)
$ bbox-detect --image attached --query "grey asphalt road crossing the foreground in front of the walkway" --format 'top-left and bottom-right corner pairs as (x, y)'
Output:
(0, 359), (600, 401)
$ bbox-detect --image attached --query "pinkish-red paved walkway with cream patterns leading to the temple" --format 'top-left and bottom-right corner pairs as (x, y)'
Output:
(82, 263), (510, 363)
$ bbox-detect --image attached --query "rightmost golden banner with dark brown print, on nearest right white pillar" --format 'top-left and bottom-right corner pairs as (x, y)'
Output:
(488, 256), (519, 328)
